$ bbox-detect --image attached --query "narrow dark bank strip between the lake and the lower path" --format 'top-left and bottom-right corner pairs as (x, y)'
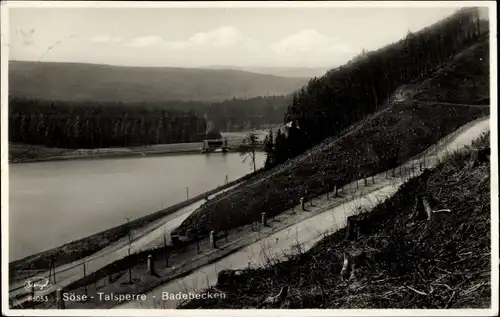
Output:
(9, 167), (261, 283)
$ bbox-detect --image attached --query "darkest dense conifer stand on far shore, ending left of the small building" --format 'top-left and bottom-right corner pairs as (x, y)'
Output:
(9, 98), (213, 149)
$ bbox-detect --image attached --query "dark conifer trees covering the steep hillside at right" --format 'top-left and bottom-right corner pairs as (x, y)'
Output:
(266, 8), (482, 168)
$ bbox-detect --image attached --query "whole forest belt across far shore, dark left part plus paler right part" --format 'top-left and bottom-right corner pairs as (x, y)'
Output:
(9, 96), (290, 148)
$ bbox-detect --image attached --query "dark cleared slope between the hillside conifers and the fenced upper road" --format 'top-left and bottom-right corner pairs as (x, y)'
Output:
(172, 39), (489, 235)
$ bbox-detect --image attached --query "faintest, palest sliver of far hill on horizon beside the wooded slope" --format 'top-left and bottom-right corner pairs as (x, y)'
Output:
(203, 66), (334, 78)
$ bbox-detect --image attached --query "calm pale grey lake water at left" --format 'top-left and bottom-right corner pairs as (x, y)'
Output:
(9, 153), (265, 262)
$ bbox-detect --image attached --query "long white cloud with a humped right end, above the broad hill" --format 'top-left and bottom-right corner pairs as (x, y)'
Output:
(123, 26), (255, 50)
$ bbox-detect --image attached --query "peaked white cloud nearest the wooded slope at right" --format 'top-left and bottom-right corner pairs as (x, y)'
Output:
(272, 29), (359, 54)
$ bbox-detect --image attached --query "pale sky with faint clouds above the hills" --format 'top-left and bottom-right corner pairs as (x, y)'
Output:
(9, 7), (488, 67)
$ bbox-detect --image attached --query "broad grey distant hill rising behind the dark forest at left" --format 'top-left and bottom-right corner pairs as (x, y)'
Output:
(9, 61), (308, 102)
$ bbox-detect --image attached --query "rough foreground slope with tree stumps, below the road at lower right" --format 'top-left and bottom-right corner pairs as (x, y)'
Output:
(181, 134), (491, 309)
